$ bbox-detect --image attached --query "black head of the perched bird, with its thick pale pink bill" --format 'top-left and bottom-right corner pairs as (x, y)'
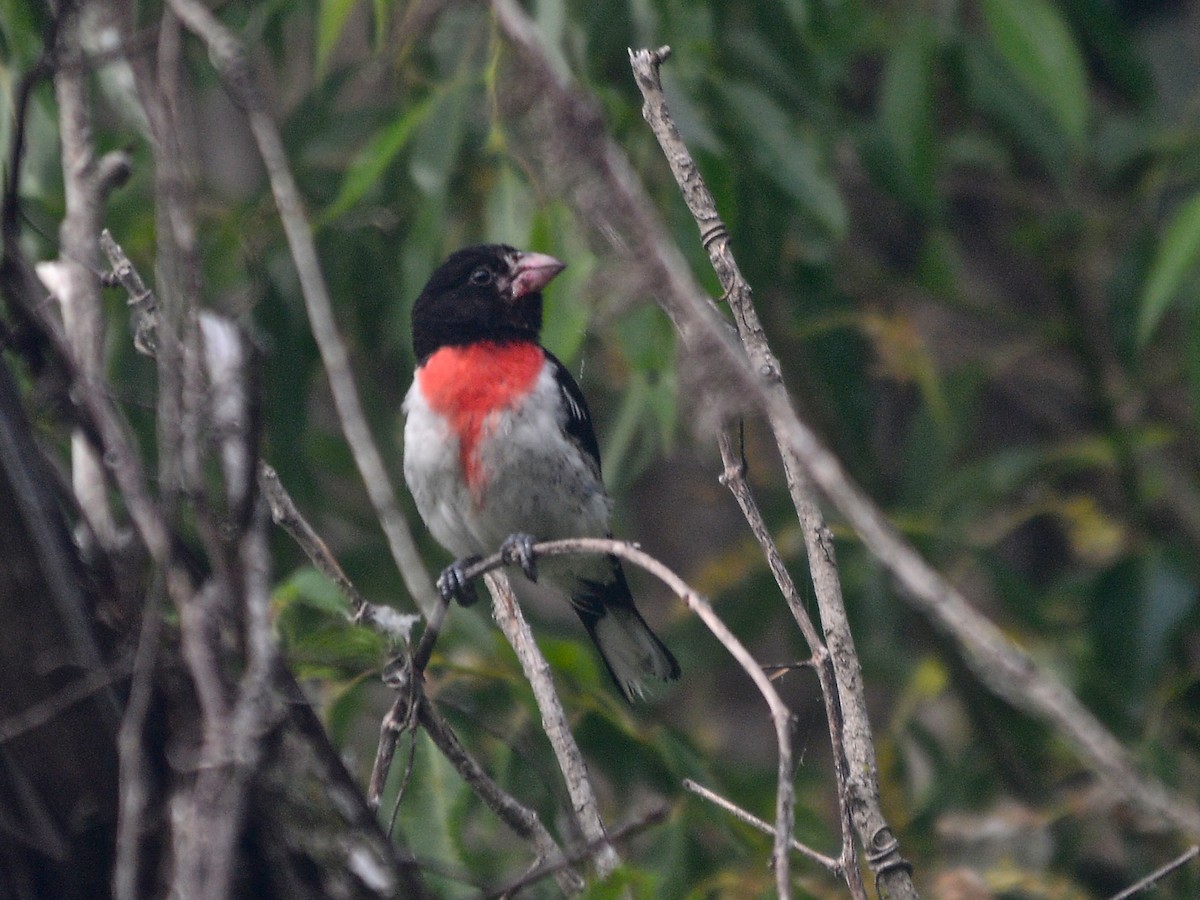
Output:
(413, 244), (564, 362)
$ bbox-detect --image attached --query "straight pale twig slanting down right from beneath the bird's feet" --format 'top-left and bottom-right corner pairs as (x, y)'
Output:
(480, 566), (620, 878)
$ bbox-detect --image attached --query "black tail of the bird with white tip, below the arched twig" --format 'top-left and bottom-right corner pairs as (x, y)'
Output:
(571, 558), (679, 703)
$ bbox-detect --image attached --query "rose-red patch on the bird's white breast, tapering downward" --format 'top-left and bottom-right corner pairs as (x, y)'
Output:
(416, 341), (546, 498)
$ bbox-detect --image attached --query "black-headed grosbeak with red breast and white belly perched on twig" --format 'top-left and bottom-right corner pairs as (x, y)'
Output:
(404, 245), (679, 701)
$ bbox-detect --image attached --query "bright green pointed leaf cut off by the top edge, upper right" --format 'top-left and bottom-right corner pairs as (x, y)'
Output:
(983, 0), (1088, 146)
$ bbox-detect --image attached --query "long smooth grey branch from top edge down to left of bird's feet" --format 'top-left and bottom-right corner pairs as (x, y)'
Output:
(170, 0), (438, 617)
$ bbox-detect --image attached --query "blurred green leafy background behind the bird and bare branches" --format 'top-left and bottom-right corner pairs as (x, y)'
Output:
(0, 0), (1200, 898)
